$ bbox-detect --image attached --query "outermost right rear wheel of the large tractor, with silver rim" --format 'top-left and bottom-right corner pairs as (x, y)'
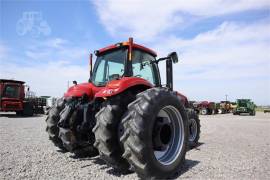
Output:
(120, 88), (188, 179)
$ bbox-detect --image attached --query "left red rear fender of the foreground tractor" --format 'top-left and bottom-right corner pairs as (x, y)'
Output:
(64, 83), (104, 99)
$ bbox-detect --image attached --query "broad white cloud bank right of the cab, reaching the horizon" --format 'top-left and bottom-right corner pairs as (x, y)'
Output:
(152, 21), (270, 104)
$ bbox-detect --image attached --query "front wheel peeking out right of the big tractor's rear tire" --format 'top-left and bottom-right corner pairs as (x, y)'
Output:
(187, 109), (201, 149)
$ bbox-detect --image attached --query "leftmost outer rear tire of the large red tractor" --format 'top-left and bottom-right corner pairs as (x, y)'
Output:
(46, 98), (66, 150)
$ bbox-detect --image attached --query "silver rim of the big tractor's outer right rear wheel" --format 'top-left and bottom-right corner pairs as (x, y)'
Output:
(153, 106), (184, 165)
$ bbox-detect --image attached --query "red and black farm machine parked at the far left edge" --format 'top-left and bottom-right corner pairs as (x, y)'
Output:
(0, 79), (46, 116)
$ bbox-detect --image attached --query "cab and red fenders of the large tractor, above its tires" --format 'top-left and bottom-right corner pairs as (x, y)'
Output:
(64, 38), (179, 99)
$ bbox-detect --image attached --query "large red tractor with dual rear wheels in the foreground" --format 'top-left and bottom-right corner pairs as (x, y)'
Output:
(46, 38), (200, 178)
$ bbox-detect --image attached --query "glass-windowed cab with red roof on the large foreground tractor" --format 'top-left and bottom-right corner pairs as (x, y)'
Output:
(91, 40), (160, 86)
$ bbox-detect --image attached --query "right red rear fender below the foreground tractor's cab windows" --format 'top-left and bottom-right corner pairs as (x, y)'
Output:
(95, 77), (153, 98)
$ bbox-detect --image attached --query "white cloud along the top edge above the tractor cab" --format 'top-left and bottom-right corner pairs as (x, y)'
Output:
(94, 0), (270, 41)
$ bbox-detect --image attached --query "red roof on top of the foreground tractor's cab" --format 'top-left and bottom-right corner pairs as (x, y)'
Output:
(98, 41), (157, 57)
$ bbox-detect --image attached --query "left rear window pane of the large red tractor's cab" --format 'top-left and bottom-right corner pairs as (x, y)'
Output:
(92, 48), (127, 86)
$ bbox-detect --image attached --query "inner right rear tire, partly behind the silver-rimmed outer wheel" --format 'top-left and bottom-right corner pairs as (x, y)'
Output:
(93, 93), (134, 173)
